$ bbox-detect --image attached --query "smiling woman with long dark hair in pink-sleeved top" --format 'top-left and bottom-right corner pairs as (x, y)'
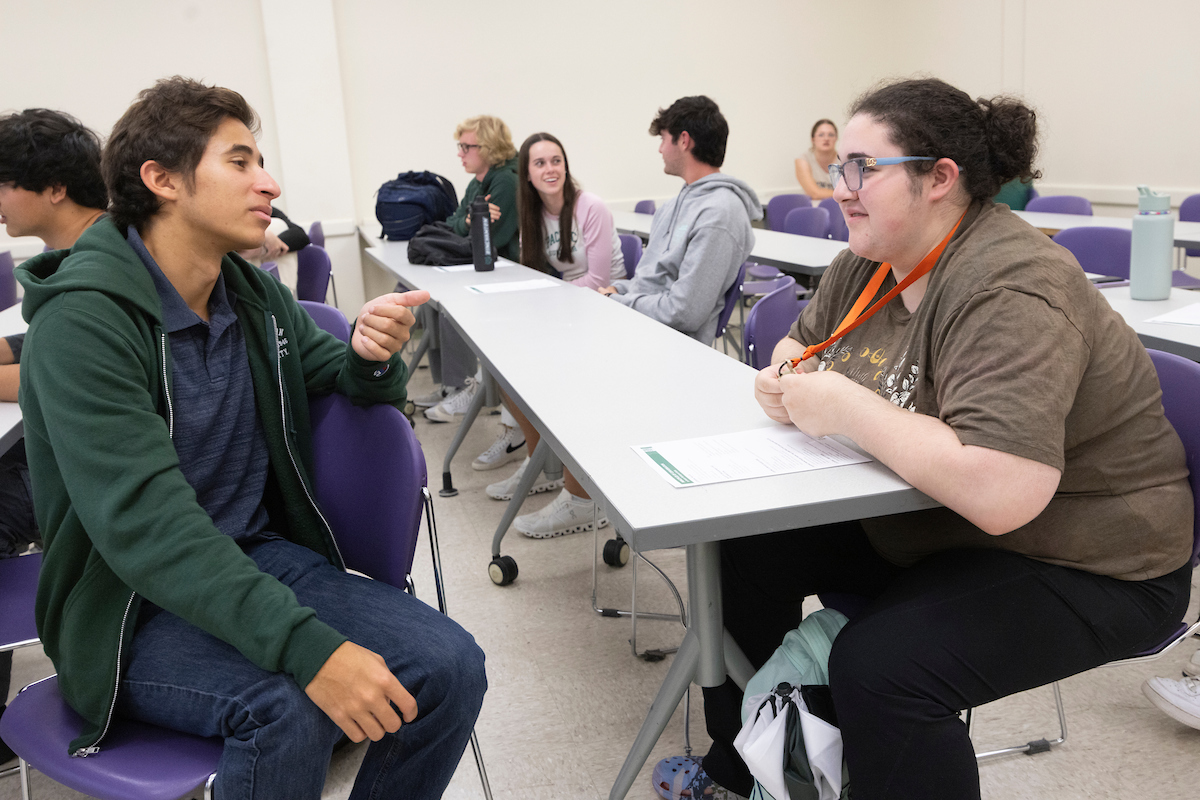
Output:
(480, 133), (625, 539)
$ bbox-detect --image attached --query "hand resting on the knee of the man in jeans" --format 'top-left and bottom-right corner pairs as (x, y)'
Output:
(304, 642), (416, 741)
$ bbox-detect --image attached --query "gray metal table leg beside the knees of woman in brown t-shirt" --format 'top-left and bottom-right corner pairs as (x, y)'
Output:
(608, 542), (729, 800)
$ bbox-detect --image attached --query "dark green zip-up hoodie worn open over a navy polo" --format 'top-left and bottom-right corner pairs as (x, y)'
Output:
(17, 219), (407, 752)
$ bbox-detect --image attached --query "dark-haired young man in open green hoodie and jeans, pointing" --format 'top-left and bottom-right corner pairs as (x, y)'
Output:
(18, 77), (486, 800)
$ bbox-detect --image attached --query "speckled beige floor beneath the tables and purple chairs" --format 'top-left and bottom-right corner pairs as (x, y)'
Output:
(7, 357), (1200, 800)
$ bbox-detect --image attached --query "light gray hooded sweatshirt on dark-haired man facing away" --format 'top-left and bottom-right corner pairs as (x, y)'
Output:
(612, 173), (762, 344)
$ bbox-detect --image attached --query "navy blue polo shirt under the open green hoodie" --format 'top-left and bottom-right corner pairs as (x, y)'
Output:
(127, 225), (272, 545)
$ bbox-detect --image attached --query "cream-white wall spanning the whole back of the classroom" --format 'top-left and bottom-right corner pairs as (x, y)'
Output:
(0, 0), (1200, 299)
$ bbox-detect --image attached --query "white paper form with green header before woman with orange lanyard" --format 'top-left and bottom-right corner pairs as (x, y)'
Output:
(634, 425), (870, 488)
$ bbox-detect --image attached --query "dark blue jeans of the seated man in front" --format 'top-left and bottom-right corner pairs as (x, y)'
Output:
(118, 540), (487, 800)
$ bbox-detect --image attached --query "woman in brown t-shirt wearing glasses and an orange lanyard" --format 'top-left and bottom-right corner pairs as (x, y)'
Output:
(681, 79), (1193, 800)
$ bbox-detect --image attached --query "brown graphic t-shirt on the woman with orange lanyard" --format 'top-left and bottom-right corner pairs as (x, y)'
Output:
(791, 204), (1193, 581)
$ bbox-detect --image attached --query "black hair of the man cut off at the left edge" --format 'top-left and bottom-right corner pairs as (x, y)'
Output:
(0, 108), (108, 209)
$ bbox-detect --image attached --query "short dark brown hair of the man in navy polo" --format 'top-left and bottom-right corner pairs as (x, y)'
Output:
(101, 76), (258, 230)
